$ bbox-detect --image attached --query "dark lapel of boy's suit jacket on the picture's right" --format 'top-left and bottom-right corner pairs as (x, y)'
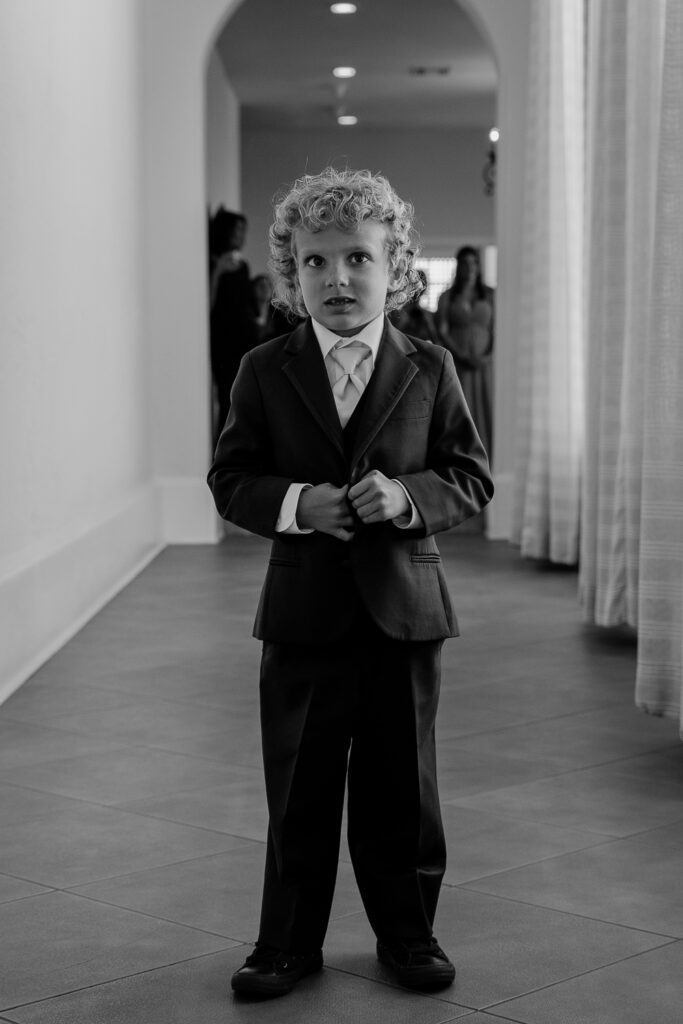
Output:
(350, 321), (419, 467)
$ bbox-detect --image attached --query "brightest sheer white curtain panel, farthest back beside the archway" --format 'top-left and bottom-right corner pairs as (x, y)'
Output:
(512, 0), (585, 564)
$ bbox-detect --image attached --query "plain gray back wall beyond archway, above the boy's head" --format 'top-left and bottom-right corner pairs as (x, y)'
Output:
(242, 125), (495, 273)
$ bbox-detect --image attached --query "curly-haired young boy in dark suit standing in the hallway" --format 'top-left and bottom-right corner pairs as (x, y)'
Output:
(209, 168), (493, 995)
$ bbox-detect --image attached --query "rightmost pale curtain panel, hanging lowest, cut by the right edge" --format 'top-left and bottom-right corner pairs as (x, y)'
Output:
(636, 0), (683, 721)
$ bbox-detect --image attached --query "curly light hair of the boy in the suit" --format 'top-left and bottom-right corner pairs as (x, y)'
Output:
(268, 167), (422, 316)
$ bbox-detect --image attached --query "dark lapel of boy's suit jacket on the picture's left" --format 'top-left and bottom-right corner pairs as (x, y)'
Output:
(283, 321), (344, 455)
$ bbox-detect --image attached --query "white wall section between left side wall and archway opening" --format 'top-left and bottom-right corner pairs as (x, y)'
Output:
(138, 0), (238, 543)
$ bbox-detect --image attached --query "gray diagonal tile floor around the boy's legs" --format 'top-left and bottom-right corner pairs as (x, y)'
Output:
(0, 534), (683, 1024)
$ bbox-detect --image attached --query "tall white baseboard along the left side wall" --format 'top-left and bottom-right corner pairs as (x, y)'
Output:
(0, 483), (164, 703)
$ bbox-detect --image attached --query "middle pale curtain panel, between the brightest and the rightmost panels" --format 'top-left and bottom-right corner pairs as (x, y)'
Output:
(580, 0), (666, 627)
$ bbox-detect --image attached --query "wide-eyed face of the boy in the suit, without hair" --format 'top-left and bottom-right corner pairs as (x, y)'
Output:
(294, 220), (395, 337)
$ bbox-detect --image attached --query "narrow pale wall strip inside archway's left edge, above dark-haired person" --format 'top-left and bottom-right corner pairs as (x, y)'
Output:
(206, 49), (242, 212)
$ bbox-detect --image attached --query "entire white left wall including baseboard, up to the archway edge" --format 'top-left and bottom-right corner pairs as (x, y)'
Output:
(0, 0), (239, 700)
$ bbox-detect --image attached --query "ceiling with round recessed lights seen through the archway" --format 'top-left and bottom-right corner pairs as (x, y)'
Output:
(216, 0), (498, 131)
